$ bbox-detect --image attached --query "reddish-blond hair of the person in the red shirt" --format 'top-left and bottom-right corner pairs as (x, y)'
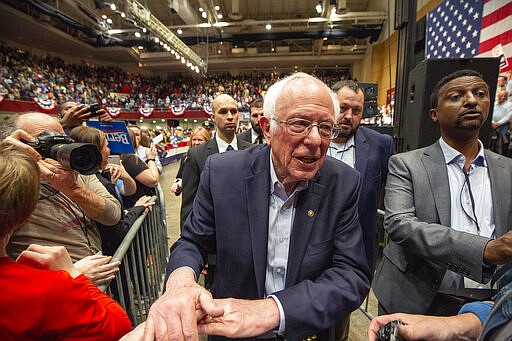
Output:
(0, 142), (40, 238)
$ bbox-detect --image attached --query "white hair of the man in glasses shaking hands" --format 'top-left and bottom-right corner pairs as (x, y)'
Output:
(263, 72), (340, 135)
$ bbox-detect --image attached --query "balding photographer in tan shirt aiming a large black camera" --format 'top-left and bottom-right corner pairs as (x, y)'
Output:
(0, 113), (121, 284)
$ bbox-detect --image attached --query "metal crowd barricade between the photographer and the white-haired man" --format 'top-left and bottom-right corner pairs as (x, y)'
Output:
(100, 188), (169, 326)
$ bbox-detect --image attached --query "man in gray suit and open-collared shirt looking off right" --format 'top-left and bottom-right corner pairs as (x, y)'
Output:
(372, 70), (512, 315)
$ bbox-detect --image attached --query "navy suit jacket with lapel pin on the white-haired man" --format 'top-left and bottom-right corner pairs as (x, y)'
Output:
(168, 145), (369, 340)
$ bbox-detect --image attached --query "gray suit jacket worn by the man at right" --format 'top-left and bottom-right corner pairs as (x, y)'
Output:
(372, 142), (512, 314)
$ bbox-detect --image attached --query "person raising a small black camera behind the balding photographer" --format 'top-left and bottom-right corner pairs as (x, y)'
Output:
(58, 102), (112, 133)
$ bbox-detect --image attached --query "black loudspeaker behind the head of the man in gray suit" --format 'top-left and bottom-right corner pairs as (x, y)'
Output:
(399, 58), (499, 151)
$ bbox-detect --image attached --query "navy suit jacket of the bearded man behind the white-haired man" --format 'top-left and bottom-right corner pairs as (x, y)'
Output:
(354, 127), (395, 269)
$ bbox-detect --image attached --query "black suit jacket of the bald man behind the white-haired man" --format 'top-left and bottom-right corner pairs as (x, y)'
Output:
(180, 137), (253, 226)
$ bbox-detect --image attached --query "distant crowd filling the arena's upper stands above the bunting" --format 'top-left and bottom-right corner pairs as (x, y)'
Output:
(0, 43), (350, 111)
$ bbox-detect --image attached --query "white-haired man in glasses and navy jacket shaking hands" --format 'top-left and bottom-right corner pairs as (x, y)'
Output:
(140, 73), (369, 340)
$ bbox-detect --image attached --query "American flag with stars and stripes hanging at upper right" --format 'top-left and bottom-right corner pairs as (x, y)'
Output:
(425, 0), (512, 72)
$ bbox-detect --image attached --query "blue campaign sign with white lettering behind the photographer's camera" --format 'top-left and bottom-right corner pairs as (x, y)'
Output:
(87, 121), (135, 154)
